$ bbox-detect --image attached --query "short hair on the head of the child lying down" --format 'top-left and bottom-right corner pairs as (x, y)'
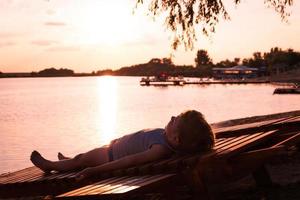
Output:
(178, 110), (215, 153)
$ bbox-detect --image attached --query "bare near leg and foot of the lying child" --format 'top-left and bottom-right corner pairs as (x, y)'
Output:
(30, 147), (109, 172)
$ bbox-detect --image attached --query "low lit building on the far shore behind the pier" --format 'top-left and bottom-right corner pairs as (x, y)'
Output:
(212, 65), (259, 79)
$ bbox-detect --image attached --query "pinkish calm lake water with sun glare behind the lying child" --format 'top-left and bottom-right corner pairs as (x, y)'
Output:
(0, 77), (300, 174)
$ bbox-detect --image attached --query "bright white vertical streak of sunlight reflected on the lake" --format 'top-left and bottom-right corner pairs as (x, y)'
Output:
(98, 76), (118, 144)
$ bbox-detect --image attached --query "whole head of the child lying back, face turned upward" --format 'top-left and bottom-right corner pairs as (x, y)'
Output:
(166, 110), (215, 153)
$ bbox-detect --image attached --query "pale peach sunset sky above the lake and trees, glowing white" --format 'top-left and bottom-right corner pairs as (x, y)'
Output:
(0, 0), (300, 72)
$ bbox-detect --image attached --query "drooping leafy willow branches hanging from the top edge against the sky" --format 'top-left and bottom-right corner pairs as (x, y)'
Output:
(136, 0), (293, 49)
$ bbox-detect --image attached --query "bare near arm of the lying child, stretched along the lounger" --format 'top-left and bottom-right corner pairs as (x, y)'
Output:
(76, 144), (171, 180)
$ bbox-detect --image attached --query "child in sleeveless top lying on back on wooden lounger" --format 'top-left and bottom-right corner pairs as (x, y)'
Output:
(30, 110), (215, 180)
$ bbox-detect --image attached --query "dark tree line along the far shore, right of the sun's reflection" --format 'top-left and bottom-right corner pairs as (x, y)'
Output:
(96, 47), (300, 77)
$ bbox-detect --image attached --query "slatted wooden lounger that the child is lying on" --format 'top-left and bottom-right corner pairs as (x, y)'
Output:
(0, 131), (274, 197)
